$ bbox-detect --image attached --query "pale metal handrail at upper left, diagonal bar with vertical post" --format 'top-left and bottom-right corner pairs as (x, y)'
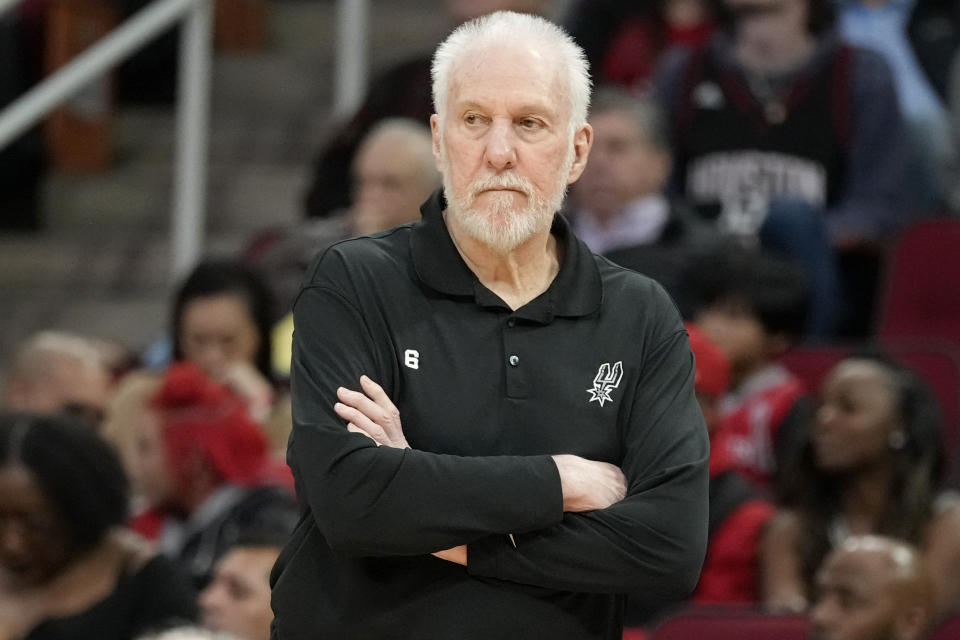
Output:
(0, 0), (213, 279)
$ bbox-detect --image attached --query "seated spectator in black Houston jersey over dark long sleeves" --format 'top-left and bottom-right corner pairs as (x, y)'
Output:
(655, 0), (914, 335)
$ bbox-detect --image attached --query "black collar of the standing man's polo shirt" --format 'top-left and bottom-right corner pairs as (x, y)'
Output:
(410, 189), (603, 324)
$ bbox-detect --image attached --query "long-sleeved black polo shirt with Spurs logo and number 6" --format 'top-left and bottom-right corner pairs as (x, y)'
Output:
(273, 192), (708, 640)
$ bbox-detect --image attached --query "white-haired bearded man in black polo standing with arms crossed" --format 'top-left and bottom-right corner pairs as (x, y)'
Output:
(272, 12), (708, 640)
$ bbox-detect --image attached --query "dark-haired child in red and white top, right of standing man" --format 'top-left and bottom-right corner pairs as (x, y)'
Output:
(689, 250), (812, 493)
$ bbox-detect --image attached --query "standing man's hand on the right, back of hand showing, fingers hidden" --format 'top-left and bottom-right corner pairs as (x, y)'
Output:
(552, 455), (627, 512)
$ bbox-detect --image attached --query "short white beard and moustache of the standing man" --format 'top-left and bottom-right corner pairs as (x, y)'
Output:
(442, 148), (574, 255)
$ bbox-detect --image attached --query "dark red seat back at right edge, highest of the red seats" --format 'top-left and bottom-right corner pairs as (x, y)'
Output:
(876, 218), (960, 346)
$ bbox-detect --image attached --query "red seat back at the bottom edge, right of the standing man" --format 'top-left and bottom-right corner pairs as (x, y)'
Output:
(650, 610), (809, 640)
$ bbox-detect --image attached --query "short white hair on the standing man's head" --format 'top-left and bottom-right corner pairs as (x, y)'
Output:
(430, 11), (590, 132)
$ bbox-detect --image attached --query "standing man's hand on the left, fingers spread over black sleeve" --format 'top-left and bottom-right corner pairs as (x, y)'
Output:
(333, 376), (410, 449)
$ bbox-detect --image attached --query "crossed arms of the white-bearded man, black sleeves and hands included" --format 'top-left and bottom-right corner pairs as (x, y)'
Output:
(288, 286), (709, 598)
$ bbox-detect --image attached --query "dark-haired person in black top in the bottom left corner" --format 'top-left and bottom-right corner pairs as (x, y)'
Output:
(0, 414), (196, 640)
